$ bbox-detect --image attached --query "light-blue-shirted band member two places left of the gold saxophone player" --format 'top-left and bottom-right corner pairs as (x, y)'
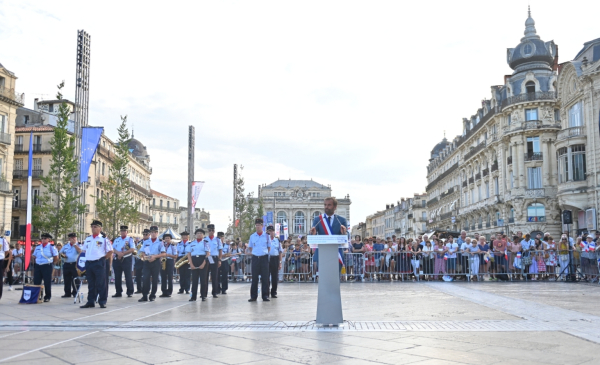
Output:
(138, 226), (165, 302)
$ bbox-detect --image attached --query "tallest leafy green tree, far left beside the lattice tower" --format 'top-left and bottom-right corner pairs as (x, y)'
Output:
(32, 81), (85, 240)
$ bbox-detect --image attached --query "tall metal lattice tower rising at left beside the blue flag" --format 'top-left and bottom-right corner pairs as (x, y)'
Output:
(74, 30), (91, 233)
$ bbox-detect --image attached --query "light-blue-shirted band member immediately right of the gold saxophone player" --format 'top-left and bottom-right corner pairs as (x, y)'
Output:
(187, 228), (210, 302)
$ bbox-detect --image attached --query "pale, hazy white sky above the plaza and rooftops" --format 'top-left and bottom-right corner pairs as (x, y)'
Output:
(0, 0), (600, 229)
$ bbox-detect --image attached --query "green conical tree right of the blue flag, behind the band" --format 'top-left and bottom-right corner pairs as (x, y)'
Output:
(95, 116), (140, 237)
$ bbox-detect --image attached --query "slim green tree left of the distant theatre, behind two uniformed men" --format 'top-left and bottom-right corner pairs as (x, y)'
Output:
(231, 166), (264, 242)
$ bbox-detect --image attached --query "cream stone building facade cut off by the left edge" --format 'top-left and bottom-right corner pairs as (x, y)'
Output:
(0, 64), (24, 236)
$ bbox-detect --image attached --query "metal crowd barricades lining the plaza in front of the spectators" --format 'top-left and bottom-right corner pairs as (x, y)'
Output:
(5, 247), (600, 284)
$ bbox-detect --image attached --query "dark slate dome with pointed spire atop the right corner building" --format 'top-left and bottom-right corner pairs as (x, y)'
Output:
(506, 7), (557, 74)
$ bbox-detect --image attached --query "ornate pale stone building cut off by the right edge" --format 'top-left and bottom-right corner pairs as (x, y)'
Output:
(555, 38), (600, 232)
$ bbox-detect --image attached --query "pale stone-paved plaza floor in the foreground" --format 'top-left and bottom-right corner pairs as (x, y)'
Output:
(0, 283), (600, 365)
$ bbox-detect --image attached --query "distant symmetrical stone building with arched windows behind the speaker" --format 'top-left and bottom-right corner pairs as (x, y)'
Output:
(258, 179), (351, 235)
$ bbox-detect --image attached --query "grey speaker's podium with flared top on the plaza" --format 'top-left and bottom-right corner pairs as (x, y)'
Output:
(307, 235), (348, 326)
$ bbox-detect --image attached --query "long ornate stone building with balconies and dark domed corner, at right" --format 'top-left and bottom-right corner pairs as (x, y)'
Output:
(427, 9), (561, 237)
